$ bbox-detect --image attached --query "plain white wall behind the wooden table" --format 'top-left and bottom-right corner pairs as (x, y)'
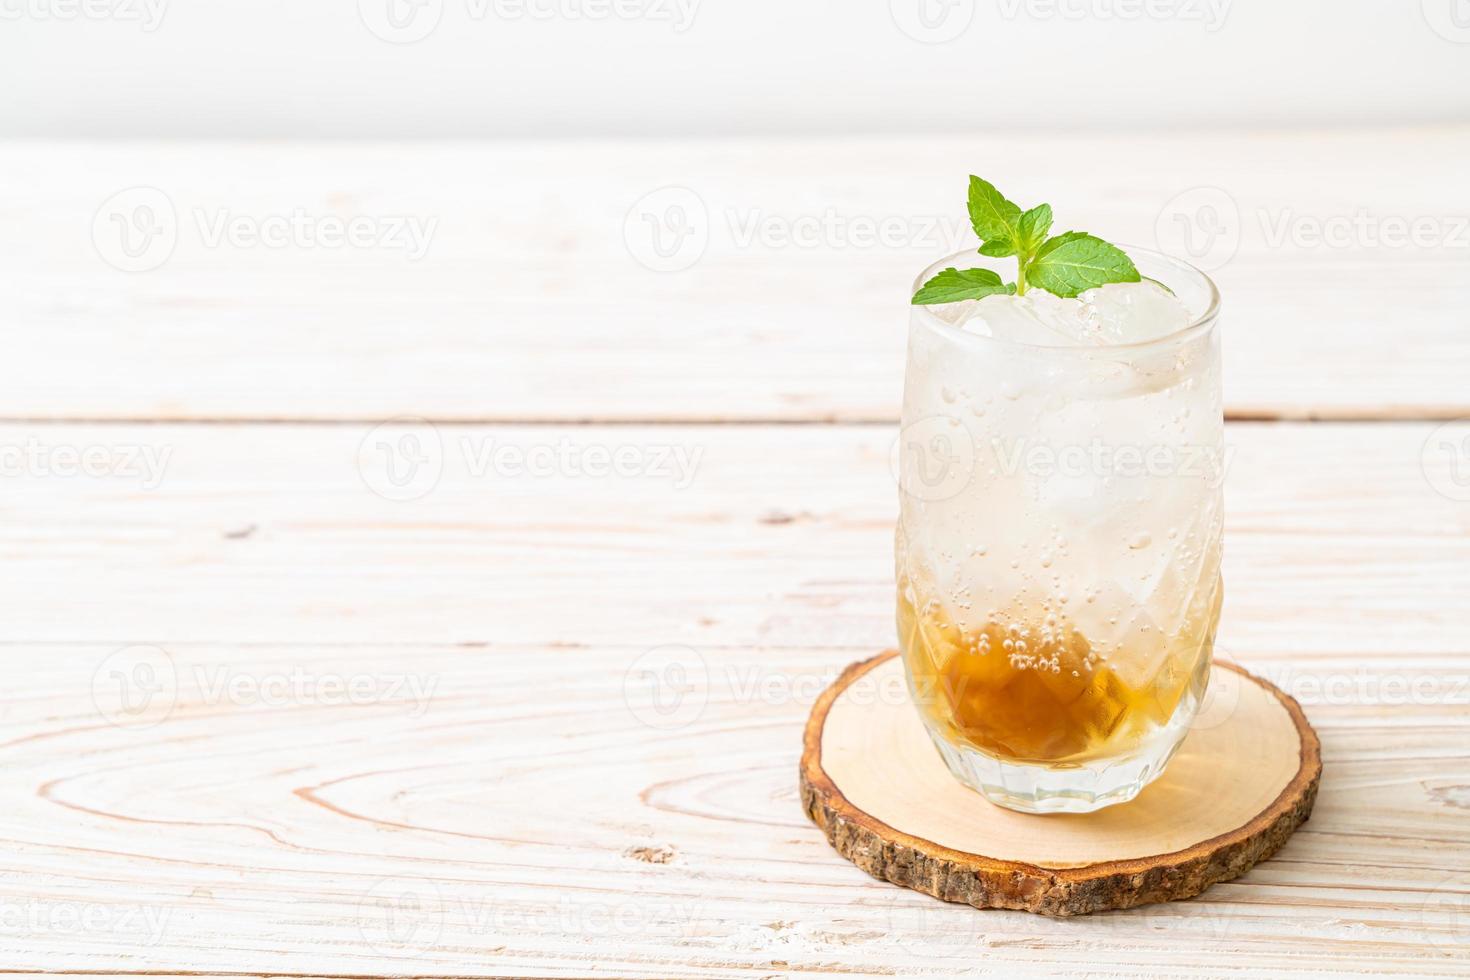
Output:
(0, 0), (1470, 137)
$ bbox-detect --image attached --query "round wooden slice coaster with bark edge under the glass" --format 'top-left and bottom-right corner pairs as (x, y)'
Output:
(801, 651), (1322, 915)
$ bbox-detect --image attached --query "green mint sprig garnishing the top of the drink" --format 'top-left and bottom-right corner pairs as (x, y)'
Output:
(913, 175), (1139, 306)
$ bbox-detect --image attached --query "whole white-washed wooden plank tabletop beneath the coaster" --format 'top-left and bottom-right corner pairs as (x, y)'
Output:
(0, 129), (1470, 977)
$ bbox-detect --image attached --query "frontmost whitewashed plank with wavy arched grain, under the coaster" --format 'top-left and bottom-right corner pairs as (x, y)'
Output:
(0, 644), (1470, 977)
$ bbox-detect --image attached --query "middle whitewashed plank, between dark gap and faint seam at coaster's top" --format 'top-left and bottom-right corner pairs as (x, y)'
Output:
(0, 423), (1470, 655)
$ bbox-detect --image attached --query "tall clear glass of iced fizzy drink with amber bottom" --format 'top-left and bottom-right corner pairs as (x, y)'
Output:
(897, 248), (1226, 813)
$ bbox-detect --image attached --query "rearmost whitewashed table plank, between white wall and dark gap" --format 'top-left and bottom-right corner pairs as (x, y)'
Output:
(0, 128), (1470, 422)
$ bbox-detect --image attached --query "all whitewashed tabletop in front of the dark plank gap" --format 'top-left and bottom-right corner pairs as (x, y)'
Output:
(0, 423), (1470, 977)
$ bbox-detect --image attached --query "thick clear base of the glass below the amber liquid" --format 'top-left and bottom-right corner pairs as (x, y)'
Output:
(929, 691), (1200, 814)
